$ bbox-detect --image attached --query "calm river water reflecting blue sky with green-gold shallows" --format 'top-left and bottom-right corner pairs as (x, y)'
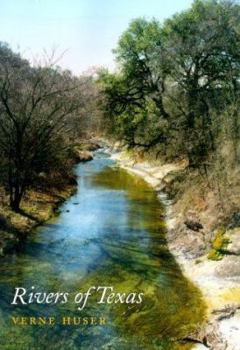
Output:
(0, 152), (204, 350)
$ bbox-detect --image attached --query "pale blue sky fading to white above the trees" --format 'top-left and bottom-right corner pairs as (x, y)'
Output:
(0, 0), (192, 74)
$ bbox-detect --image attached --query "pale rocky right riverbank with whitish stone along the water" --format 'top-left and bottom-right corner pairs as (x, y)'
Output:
(112, 147), (240, 350)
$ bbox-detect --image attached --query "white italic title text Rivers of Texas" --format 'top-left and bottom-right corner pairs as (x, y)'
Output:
(11, 286), (144, 311)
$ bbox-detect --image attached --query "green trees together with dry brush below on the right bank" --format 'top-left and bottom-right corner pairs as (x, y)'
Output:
(98, 0), (240, 241)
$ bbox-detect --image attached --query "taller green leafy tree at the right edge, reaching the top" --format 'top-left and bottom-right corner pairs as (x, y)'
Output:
(163, 0), (240, 161)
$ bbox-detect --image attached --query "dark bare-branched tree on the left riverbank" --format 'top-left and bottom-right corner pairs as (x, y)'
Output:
(0, 46), (81, 211)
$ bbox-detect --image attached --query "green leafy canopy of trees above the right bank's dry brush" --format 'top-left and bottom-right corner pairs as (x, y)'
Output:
(98, 0), (240, 166)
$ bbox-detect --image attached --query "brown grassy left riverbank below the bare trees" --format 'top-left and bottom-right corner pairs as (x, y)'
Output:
(0, 141), (100, 257)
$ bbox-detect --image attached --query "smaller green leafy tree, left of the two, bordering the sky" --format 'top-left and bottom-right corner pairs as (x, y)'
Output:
(99, 19), (169, 148)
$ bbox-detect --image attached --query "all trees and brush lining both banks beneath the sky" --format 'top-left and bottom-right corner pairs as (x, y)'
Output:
(0, 0), (240, 258)
